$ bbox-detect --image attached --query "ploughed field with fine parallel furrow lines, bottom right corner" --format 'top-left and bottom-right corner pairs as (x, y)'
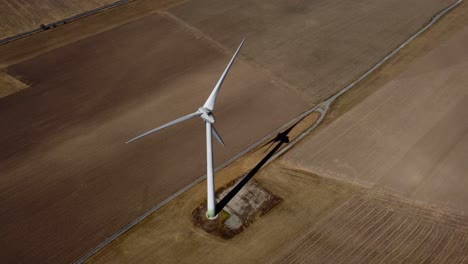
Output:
(272, 194), (468, 263)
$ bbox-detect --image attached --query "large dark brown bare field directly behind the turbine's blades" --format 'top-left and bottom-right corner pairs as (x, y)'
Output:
(0, 12), (309, 263)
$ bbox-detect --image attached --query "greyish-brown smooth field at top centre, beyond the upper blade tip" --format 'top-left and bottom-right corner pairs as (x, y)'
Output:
(169, 0), (454, 103)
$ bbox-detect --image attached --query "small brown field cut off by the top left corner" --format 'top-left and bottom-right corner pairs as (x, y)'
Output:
(0, 0), (116, 39)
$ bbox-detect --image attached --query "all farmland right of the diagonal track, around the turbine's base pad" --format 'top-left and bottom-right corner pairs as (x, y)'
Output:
(90, 1), (468, 263)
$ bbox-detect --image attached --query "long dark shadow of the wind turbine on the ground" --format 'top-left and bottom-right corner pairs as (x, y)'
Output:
(216, 120), (301, 214)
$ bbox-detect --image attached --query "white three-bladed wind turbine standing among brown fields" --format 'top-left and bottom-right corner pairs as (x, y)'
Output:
(127, 38), (245, 219)
